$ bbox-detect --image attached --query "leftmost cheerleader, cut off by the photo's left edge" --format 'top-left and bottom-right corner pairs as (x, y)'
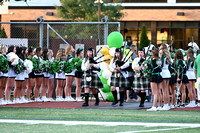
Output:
(0, 45), (8, 105)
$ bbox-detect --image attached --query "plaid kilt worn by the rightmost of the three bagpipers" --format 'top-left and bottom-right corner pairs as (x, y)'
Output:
(132, 76), (150, 91)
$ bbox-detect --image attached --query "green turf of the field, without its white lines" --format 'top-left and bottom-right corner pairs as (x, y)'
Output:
(0, 107), (200, 133)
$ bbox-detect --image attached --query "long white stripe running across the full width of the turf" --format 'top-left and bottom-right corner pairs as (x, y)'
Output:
(0, 119), (200, 128)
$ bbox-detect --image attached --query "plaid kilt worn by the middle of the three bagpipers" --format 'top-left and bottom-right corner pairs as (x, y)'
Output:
(110, 73), (130, 88)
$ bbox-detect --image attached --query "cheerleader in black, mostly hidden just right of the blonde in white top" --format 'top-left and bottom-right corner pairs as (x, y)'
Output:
(169, 60), (176, 109)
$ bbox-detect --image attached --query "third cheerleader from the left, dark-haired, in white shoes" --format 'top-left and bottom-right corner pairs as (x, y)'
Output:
(13, 47), (25, 103)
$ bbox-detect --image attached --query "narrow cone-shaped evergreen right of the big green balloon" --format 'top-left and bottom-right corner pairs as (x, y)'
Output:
(139, 24), (150, 48)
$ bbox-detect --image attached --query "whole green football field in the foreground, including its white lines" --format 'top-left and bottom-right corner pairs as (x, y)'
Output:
(0, 107), (200, 133)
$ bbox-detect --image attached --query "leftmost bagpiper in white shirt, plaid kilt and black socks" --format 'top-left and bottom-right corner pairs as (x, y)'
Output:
(81, 48), (103, 107)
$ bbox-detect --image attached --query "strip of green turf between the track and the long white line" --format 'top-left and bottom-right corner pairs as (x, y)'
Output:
(0, 107), (200, 123)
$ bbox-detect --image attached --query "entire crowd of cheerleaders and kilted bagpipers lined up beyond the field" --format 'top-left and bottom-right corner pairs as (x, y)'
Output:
(0, 44), (200, 111)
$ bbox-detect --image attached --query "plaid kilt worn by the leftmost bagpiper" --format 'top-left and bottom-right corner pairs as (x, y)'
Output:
(81, 72), (104, 89)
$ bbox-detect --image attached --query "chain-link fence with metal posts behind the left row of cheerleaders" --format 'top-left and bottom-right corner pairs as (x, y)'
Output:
(0, 22), (120, 53)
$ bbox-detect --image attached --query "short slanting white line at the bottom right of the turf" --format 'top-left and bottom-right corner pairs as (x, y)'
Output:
(120, 127), (193, 133)
